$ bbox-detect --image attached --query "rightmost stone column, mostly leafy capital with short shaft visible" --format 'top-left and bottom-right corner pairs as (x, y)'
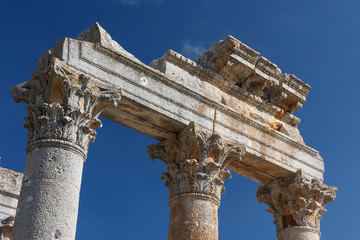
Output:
(256, 170), (337, 240)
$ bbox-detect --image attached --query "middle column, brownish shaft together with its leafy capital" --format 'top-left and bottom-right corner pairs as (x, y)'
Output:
(148, 123), (245, 240)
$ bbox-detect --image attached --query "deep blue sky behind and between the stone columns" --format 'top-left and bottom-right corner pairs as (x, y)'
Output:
(0, 0), (360, 240)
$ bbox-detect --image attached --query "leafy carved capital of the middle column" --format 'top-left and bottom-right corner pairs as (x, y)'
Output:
(148, 123), (245, 204)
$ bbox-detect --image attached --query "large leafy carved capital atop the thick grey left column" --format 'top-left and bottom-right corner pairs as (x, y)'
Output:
(11, 58), (121, 154)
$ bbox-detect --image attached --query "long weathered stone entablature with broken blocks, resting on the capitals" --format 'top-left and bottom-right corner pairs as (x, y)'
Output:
(38, 24), (324, 183)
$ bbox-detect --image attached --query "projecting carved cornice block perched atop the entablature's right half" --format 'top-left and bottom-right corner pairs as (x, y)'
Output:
(196, 36), (310, 113)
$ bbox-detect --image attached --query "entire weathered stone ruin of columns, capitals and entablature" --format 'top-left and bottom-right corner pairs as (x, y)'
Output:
(1, 23), (337, 240)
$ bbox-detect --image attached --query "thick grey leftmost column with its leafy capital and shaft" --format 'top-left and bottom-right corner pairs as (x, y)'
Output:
(12, 58), (120, 240)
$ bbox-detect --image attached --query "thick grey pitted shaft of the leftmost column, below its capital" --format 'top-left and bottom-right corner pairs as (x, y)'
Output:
(13, 143), (85, 239)
